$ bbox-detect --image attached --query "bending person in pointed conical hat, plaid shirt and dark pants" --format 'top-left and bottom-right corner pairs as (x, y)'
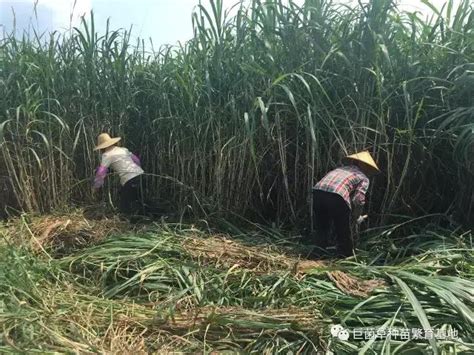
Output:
(313, 151), (380, 256)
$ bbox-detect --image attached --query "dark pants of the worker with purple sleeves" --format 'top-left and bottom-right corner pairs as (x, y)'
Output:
(120, 175), (162, 216)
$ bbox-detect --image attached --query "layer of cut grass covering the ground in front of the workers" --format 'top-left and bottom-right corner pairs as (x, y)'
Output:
(0, 211), (474, 354)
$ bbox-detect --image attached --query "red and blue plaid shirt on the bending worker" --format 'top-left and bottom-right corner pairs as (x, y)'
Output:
(313, 165), (369, 208)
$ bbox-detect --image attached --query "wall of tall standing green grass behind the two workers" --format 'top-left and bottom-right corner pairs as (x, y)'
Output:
(0, 0), (474, 222)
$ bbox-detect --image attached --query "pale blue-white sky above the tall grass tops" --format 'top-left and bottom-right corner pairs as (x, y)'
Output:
(0, 0), (459, 47)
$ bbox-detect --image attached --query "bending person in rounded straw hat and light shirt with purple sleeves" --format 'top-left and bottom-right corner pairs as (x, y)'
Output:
(93, 133), (156, 215)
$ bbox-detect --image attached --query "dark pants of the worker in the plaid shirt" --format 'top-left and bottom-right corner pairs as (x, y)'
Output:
(313, 190), (353, 256)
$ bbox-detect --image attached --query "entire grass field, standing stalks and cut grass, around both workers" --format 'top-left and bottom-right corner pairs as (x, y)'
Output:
(0, 0), (474, 354)
